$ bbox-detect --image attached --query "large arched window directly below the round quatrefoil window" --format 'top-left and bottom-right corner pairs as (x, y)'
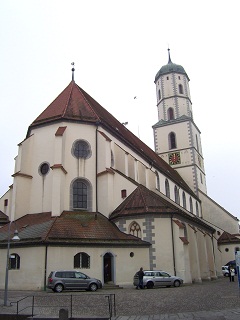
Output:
(71, 179), (92, 211)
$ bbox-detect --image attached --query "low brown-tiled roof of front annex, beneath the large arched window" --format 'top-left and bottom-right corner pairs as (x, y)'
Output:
(0, 211), (150, 246)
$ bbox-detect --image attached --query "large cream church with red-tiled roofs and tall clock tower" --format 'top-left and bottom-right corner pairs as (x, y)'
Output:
(0, 50), (240, 290)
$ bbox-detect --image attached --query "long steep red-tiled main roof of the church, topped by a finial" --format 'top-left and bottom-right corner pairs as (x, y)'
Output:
(27, 81), (196, 197)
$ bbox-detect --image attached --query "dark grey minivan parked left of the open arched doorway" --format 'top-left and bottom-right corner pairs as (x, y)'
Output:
(47, 270), (102, 292)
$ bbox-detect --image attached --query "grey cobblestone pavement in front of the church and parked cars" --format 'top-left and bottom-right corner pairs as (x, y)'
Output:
(0, 278), (240, 320)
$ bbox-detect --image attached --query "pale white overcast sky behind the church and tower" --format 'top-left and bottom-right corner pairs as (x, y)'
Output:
(0, 0), (240, 219)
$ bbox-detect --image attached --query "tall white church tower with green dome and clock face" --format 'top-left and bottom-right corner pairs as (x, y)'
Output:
(153, 49), (207, 195)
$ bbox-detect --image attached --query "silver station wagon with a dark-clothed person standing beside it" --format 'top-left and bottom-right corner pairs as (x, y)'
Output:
(133, 270), (183, 289)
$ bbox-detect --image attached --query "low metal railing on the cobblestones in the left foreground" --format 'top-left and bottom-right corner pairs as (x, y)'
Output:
(11, 293), (116, 319)
